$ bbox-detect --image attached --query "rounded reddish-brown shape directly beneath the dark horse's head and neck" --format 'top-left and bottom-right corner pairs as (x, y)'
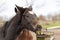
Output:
(16, 29), (36, 40)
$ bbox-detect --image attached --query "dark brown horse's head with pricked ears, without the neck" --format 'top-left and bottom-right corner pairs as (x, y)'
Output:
(15, 5), (38, 31)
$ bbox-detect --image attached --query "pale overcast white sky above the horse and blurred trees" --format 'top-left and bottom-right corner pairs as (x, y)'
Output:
(0, 0), (60, 18)
